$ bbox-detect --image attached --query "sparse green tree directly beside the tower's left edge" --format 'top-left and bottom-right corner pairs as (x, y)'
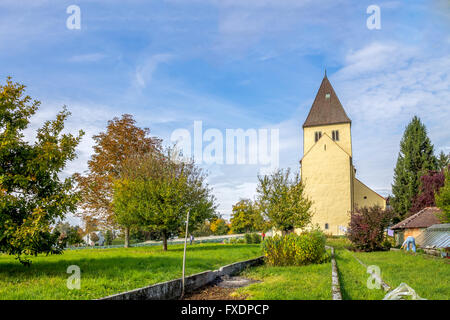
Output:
(256, 169), (312, 234)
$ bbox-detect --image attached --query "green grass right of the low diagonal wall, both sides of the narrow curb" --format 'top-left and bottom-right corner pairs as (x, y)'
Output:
(236, 238), (450, 300)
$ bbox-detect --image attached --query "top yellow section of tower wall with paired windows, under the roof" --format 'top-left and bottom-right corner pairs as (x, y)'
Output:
(303, 123), (352, 157)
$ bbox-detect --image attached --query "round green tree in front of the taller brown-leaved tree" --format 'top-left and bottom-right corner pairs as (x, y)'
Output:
(113, 149), (216, 251)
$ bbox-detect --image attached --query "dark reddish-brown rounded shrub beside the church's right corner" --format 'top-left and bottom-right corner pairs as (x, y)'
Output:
(348, 206), (394, 251)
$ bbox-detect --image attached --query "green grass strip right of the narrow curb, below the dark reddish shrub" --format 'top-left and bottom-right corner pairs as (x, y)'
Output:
(327, 238), (450, 300)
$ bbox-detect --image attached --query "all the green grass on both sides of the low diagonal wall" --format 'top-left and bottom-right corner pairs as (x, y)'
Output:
(0, 238), (450, 300)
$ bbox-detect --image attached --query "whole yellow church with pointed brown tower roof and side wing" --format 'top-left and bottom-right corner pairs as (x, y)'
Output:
(300, 73), (386, 235)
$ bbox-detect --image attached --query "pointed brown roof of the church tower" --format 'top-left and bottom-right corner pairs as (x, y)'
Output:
(303, 71), (352, 128)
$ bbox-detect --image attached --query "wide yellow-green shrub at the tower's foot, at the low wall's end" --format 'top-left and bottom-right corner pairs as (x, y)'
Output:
(263, 230), (328, 266)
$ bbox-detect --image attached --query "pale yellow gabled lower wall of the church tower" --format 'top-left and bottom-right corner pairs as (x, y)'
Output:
(301, 134), (353, 235)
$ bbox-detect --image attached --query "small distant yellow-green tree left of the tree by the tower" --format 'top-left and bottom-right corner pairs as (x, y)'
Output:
(231, 199), (264, 233)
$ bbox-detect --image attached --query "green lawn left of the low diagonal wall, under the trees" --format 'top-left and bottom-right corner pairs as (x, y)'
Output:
(0, 243), (261, 299)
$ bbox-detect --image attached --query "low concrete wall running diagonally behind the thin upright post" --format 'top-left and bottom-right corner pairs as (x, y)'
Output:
(98, 256), (264, 300)
